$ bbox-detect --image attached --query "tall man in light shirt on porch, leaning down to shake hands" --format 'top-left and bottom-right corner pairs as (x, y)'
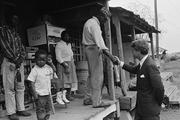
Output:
(82, 7), (117, 108)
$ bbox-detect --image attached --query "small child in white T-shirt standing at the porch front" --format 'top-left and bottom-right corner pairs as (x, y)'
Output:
(27, 50), (57, 120)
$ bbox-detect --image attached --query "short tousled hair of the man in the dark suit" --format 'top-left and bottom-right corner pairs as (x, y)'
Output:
(131, 39), (149, 55)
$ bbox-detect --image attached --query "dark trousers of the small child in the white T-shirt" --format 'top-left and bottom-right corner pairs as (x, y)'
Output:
(36, 95), (51, 120)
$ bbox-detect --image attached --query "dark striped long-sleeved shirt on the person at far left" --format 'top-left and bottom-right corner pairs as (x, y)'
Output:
(0, 26), (25, 63)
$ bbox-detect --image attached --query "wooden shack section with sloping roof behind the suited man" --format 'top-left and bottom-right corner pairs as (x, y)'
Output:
(110, 7), (159, 87)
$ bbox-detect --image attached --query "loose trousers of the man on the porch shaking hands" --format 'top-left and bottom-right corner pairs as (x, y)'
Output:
(85, 46), (103, 106)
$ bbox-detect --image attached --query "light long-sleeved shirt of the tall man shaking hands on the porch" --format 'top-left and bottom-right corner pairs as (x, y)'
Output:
(82, 16), (108, 49)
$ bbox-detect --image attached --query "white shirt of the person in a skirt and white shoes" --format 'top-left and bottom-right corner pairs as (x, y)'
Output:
(55, 40), (73, 63)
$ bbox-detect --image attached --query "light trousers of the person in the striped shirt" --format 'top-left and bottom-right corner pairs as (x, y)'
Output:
(1, 58), (25, 115)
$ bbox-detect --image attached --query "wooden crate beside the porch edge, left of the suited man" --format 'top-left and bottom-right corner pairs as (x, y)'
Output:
(119, 91), (137, 111)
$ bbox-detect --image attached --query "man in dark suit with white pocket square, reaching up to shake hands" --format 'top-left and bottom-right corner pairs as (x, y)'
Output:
(120, 40), (164, 120)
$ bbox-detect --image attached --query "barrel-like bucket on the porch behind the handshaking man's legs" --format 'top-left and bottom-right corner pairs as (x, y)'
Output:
(76, 61), (89, 93)
